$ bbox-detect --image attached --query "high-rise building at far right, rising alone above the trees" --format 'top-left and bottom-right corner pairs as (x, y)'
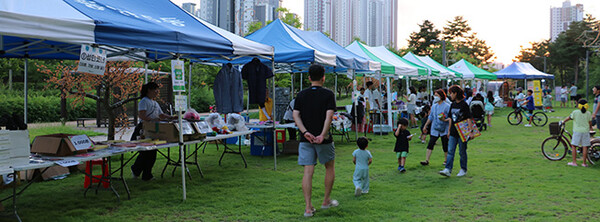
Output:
(550, 0), (583, 41)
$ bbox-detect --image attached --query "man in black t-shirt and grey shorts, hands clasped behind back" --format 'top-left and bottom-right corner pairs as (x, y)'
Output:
(293, 65), (338, 217)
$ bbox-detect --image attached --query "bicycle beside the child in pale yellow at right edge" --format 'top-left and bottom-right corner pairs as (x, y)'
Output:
(541, 122), (600, 165)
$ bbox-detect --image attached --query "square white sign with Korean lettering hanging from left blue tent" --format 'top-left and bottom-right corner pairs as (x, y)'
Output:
(77, 45), (106, 75)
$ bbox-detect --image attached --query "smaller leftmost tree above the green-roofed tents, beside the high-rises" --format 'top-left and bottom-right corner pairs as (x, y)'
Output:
(408, 20), (441, 55)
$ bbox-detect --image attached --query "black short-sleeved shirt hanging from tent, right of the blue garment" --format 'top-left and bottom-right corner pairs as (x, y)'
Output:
(242, 58), (273, 104)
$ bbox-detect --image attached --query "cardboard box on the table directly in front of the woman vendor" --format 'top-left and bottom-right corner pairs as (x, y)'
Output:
(143, 122), (206, 143)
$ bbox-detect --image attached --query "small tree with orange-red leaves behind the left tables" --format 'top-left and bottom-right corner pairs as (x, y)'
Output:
(38, 61), (162, 140)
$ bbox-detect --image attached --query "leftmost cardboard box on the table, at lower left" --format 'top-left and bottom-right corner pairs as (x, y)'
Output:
(31, 134), (91, 156)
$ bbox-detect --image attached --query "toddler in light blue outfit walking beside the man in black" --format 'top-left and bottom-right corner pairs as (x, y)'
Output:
(352, 137), (373, 197)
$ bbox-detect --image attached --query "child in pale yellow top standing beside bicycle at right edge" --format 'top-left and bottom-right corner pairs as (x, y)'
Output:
(560, 99), (592, 167)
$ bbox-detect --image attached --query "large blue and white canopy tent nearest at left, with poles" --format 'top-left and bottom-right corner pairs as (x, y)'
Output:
(0, 0), (273, 200)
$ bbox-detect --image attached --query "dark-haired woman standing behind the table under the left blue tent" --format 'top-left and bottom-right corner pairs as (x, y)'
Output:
(131, 82), (173, 181)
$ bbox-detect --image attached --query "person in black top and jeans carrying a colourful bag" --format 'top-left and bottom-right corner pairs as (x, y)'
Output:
(439, 85), (473, 177)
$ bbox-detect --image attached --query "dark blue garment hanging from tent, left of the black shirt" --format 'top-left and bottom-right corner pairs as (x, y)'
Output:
(213, 63), (244, 114)
